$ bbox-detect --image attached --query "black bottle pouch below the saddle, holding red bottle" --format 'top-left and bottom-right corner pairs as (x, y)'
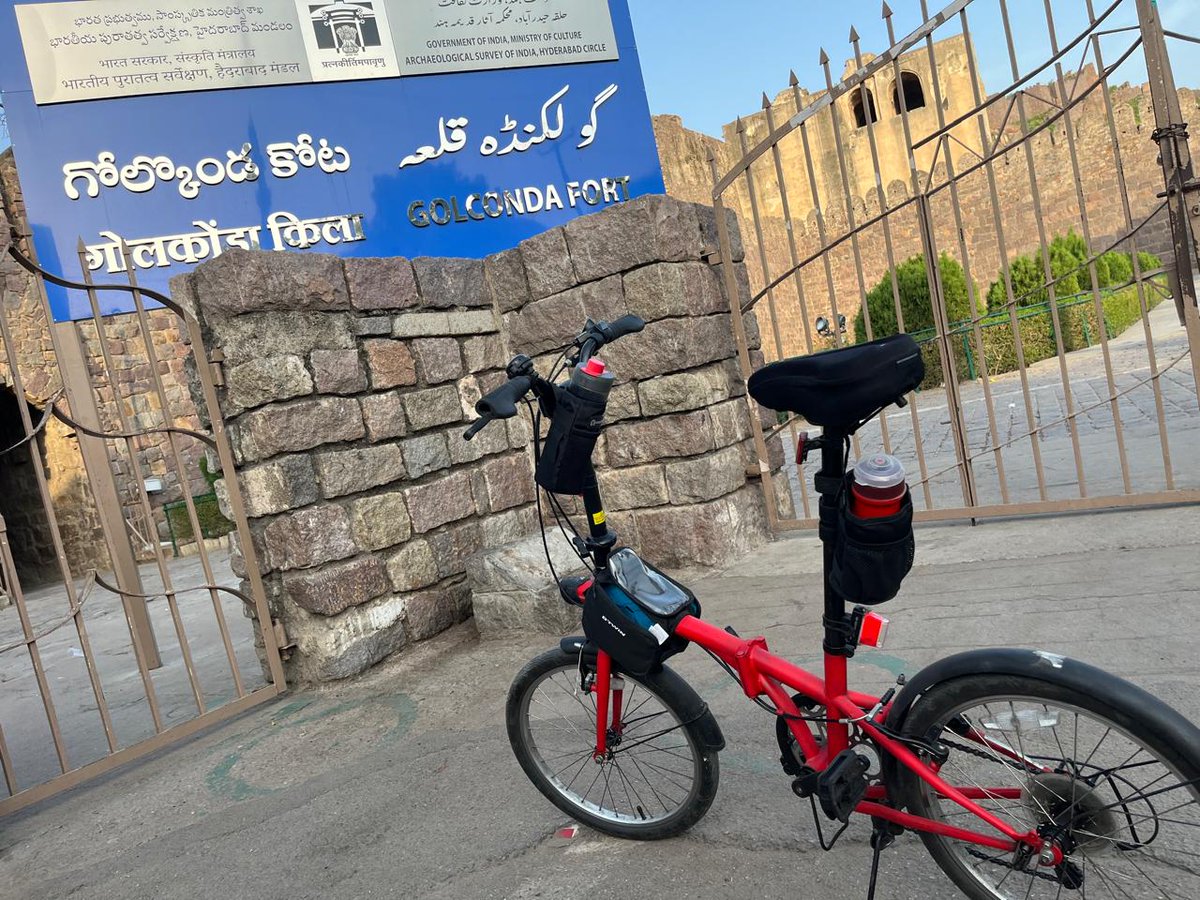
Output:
(829, 473), (917, 606)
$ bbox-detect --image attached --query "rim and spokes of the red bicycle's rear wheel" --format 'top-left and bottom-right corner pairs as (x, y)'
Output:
(922, 696), (1200, 900)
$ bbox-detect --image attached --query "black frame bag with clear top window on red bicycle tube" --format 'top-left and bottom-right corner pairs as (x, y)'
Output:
(583, 550), (701, 676)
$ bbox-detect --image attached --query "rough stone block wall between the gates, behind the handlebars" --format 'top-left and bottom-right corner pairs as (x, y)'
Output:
(172, 197), (766, 680)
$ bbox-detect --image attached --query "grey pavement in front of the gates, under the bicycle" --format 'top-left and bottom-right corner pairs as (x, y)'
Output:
(0, 508), (1200, 900)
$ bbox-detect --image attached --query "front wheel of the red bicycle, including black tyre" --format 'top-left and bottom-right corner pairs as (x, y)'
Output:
(505, 649), (719, 840)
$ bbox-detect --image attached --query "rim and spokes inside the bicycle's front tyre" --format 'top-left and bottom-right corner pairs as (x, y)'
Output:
(521, 666), (702, 826)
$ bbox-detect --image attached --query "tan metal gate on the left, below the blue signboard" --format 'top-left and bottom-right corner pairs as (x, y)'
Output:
(0, 214), (286, 815)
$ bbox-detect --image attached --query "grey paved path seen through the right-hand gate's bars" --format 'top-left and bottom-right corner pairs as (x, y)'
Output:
(788, 300), (1200, 512)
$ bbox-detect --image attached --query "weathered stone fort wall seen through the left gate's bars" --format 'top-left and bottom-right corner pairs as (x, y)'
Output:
(0, 150), (208, 580)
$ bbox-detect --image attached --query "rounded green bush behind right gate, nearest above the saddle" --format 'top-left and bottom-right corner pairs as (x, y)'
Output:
(854, 253), (971, 343)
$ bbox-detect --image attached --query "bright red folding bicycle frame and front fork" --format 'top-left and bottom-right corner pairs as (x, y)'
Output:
(593, 616), (1061, 864)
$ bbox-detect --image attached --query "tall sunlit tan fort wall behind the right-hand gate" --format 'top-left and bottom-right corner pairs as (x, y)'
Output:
(655, 57), (1200, 359)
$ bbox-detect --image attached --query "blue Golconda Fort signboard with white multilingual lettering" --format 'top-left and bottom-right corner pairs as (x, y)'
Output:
(0, 0), (664, 320)
